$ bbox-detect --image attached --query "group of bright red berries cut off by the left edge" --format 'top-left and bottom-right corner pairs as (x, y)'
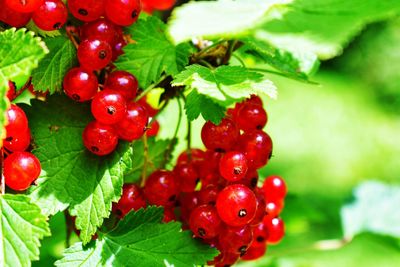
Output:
(1, 82), (41, 191)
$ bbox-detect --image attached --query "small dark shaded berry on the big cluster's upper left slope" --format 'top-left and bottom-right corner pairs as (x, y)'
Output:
(174, 163), (200, 192)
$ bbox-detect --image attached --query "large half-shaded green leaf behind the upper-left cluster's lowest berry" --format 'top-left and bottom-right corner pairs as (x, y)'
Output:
(25, 95), (132, 246)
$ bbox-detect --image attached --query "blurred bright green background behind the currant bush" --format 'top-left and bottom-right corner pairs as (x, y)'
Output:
(33, 20), (400, 267)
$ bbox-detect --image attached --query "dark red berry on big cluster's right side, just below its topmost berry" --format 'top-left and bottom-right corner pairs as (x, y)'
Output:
(237, 130), (272, 169)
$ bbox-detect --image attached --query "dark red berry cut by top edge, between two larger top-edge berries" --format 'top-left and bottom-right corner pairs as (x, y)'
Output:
(68, 0), (104, 21)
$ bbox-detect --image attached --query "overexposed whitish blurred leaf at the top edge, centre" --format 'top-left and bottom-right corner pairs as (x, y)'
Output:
(168, 0), (291, 43)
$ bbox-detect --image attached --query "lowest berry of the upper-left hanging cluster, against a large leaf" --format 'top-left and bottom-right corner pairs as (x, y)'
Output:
(82, 121), (118, 156)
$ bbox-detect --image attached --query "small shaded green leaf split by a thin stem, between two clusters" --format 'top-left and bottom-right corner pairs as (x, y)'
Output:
(125, 138), (173, 183)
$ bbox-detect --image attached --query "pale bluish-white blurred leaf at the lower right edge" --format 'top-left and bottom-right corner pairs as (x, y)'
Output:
(341, 181), (400, 238)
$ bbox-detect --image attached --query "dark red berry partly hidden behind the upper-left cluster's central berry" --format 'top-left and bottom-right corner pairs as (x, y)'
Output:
(104, 70), (139, 101)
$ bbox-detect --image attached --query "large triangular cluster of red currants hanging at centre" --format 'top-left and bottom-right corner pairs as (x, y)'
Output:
(113, 96), (286, 266)
